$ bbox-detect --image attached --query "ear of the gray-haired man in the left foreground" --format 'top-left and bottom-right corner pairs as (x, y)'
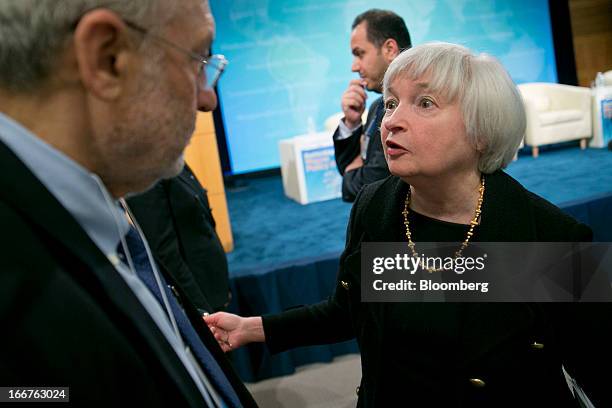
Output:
(73, 9), (133, 101)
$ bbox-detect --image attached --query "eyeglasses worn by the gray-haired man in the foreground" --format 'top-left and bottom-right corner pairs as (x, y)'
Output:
(123, 20), (229, 90)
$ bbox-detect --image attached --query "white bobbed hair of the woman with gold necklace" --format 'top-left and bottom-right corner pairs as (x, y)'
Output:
(383, 42), (526, 173)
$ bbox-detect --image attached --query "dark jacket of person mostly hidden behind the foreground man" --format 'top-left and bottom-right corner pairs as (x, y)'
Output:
(127, 165), (229, 313)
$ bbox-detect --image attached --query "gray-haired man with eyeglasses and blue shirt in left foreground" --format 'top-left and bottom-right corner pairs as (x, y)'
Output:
(0, 0), (255, 407)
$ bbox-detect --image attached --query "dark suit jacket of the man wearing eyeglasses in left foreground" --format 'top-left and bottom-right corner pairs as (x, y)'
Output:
(0, 143), (256, 407)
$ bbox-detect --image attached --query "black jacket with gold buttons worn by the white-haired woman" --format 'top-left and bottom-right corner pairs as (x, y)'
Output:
(263, 171), (612, 407)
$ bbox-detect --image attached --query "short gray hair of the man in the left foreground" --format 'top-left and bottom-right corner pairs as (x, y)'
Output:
(0, 0), (174, 92)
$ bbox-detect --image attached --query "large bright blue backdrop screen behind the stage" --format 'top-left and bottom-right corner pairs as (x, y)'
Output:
(210, 0), (557, 174)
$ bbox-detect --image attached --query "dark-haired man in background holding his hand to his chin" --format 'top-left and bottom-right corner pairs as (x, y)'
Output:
(333, 9), (411, 202)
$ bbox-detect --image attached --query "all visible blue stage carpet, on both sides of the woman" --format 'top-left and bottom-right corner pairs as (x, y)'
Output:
(227, 147), (612, 277)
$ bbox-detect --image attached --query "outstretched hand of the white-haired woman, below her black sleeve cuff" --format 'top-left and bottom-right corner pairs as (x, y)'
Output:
(203, 312), (265, 353)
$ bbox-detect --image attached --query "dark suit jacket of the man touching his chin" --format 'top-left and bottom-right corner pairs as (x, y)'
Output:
(334, 97), (390, 202)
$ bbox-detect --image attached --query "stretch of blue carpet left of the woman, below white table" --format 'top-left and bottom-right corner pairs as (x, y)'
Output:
(227, 176), (351, 276)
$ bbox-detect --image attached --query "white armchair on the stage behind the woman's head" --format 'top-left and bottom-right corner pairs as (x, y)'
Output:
(518, 83), (592, 157)
